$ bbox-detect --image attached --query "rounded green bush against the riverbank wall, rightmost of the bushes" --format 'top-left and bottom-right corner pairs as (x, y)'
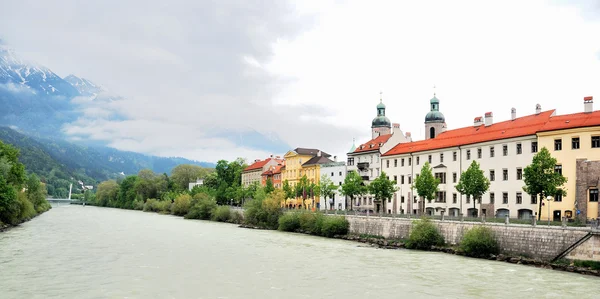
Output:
(460, 226), (500, 257)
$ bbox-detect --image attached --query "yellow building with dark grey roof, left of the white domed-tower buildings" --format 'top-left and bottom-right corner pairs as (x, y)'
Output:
(281, 148), (333, 207)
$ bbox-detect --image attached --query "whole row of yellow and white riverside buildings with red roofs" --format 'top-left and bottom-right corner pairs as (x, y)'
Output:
(242, 94), (600, 220)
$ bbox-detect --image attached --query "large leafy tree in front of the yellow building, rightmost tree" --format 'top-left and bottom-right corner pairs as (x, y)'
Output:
(523, 147), (567, 220)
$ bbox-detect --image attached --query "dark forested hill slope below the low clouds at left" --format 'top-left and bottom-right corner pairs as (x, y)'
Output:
(0, 127), (215, 197)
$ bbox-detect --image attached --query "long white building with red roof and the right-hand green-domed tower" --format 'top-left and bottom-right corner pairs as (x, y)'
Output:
(382, 96), (554, 218)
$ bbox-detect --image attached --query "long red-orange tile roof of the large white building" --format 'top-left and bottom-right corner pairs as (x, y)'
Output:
(383, 110), (554, 156)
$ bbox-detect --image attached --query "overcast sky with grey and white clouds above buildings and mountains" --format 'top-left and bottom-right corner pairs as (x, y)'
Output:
(0, 0), (600, 161)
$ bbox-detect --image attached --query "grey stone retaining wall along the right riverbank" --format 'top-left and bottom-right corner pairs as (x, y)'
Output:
(346, 215), (600, 261)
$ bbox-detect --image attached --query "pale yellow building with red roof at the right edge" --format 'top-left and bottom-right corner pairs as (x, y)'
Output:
(537, 97), (600, 220)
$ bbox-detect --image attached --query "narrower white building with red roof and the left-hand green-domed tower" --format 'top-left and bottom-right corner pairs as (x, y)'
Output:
(347, 96), (411, 212)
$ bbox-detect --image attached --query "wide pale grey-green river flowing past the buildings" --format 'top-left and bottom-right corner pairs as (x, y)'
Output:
(0, 205), (600, 299)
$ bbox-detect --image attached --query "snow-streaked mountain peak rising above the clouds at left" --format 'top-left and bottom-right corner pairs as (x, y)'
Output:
(0, 40), (79, 99)
